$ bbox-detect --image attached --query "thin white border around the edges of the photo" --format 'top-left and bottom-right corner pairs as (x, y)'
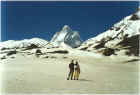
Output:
(0, 0), (140, 95)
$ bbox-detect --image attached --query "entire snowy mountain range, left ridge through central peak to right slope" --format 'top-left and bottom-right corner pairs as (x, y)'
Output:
(0, 9), (140, 56)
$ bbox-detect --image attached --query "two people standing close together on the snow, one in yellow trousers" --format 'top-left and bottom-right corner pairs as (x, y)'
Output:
(67, 60), (80, 80)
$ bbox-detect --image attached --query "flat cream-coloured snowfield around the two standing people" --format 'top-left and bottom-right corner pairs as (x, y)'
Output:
(1, 52), (139, 95)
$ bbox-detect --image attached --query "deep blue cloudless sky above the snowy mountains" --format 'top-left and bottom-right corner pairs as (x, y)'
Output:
(1, 1), (139, 41)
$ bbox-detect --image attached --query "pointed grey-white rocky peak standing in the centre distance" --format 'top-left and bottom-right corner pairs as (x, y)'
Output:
(51, 25), (82, 48)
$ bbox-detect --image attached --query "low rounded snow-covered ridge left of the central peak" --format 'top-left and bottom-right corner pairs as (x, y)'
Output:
(0, 38), (48, 49)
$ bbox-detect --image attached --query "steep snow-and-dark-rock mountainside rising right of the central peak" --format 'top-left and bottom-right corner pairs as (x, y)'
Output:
(78, 9), (140, 55)
